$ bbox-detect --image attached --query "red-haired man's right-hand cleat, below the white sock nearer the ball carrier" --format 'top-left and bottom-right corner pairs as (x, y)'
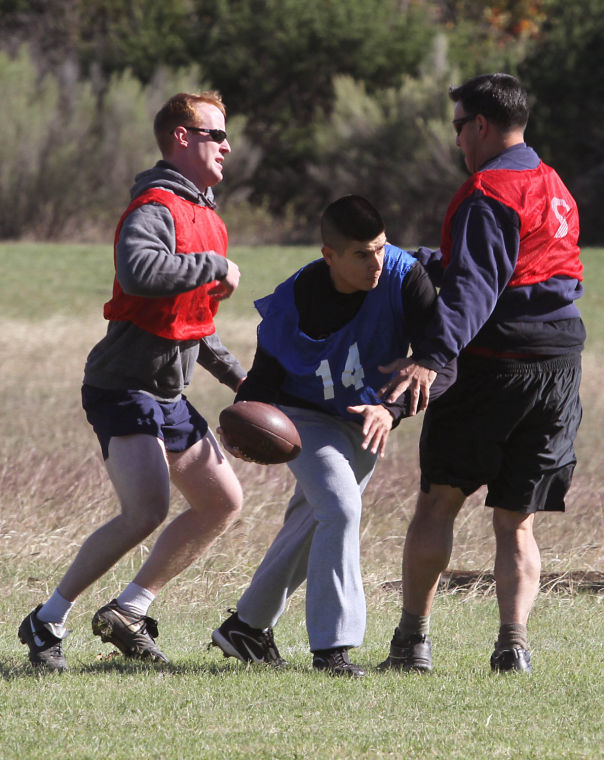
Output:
(92, 599), (168, 662)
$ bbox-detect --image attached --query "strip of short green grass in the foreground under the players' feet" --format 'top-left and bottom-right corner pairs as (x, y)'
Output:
(0, 589), (604, 760)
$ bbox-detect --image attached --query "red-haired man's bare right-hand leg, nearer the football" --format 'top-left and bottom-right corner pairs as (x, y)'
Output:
(134, 431), (243, 594)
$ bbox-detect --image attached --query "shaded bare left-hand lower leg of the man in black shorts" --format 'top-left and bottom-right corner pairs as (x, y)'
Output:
(403, 485), (465, 615)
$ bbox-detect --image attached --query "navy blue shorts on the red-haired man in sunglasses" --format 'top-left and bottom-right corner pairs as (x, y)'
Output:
(82, 384), (208, 459)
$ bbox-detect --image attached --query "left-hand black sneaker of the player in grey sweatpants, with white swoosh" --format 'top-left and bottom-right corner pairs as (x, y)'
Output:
(208, 610), (289, 668)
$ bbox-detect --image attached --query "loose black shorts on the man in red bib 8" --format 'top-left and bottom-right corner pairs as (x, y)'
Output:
(420, 354), (581, 514)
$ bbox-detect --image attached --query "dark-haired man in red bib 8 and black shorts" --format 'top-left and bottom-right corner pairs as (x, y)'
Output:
(381, 74), (585, 673)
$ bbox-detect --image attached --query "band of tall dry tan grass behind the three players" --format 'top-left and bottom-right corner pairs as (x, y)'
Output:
(0, 312), (603, 599)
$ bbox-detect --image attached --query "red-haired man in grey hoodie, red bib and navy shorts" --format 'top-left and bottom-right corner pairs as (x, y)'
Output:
(19, 92), (245, 671)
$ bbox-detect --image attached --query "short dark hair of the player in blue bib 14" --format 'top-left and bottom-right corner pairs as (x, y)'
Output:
(321, 195), (384, 251)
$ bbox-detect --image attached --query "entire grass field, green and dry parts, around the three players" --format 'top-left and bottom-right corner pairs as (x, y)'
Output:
(0, 243), (604, 760)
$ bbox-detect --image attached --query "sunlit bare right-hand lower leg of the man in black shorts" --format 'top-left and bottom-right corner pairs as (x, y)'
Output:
(493, 508), (541, 625)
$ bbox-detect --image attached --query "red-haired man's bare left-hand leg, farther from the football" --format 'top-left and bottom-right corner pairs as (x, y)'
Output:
(57, 435), (170, 602)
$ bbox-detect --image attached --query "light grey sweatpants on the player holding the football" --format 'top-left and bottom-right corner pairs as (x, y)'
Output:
(237, 407), (376, 651)
